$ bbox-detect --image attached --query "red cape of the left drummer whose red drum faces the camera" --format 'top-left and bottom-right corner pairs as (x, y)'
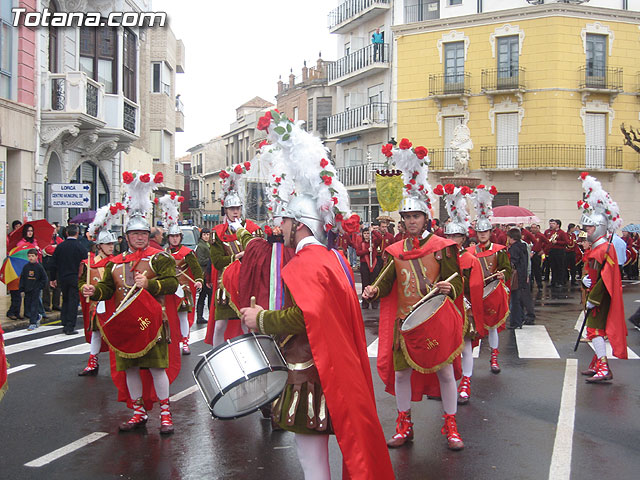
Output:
(105, 247), (182, 410)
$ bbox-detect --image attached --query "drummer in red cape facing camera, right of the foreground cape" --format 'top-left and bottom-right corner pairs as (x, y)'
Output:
(363, 138), (464, 450)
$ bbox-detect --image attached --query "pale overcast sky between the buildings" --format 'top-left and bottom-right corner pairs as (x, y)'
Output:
(153, 0), (337, 156)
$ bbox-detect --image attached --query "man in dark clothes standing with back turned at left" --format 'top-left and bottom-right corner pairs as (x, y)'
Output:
(50, 224), (87, 335)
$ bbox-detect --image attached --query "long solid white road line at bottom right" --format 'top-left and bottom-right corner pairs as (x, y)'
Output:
(549, 358), (578, 480)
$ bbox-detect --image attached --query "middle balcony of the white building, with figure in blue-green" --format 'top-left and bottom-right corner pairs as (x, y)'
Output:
(327, 43), (390, 85)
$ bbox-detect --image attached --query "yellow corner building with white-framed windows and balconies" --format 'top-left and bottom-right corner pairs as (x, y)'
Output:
(393, 3), (640, 225)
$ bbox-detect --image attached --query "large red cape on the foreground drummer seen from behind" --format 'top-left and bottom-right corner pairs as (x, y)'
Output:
(282, 245), (394, 480)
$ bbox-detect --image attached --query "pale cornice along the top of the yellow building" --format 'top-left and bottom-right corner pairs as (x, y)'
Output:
(391, 3), (640, 38)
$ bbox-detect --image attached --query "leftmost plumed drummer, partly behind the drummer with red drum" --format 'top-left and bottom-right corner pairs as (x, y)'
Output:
(78, 202), (124, 377)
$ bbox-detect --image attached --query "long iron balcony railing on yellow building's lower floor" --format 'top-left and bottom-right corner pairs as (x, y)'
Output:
(480, 144), (622, 170)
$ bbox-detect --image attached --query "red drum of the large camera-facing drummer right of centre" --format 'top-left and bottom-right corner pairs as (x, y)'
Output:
(400, 295), (464, 373)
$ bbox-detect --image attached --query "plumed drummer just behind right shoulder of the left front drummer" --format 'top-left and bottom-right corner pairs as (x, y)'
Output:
(155, 192), (204, 355)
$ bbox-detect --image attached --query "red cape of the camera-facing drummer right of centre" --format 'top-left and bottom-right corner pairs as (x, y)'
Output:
(377, 234), (462, 402)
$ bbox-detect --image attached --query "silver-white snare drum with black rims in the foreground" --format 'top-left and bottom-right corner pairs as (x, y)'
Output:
(193, 333), (288, 420)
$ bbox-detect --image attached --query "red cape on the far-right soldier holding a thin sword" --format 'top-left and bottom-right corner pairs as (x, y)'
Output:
(589, 242), (628, 359)
